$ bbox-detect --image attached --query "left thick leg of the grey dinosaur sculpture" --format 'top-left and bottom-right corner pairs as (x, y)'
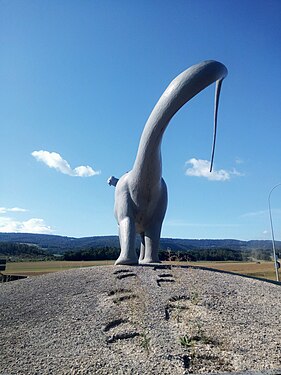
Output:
(115, 217), (138, 265)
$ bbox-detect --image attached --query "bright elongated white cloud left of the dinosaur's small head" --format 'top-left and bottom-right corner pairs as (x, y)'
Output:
(31, 150), (101, 177)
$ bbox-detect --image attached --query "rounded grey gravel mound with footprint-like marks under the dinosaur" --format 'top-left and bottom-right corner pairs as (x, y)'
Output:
(0, 266), (281, 375)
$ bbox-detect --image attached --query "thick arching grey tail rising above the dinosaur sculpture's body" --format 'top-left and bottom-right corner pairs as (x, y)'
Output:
(132, 61), (227, 184)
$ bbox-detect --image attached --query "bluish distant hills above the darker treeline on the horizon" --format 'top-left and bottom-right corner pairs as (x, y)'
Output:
(0, 233), (281, 254)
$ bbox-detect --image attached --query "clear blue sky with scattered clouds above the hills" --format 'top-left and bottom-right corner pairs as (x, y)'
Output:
(0, 0), (281, 240)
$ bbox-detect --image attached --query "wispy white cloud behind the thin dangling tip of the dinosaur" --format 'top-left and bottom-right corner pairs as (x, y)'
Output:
(185, 158), (242, 181)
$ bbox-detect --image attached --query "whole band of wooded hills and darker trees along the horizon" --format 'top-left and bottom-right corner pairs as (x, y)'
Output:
(0, 233), (276, 261)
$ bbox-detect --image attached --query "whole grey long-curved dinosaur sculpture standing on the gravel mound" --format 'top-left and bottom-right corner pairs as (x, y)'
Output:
(108, 61), (227, 264)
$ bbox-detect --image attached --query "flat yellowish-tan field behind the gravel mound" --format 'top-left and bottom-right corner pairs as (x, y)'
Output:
(3, 260), (276, 280)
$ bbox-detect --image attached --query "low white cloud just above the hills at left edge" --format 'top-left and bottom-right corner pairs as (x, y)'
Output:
(0, 217), (53, 234)
